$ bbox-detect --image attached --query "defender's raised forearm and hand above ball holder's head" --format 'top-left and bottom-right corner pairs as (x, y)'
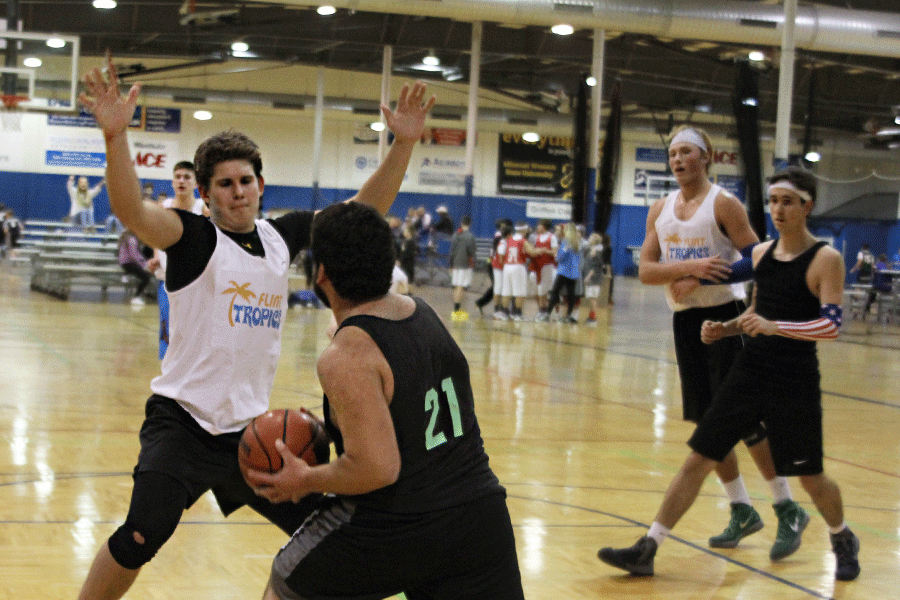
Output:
(351, 81), (435, 214)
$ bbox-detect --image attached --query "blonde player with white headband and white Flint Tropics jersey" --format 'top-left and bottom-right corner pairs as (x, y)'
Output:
(601, 126), (809, 560)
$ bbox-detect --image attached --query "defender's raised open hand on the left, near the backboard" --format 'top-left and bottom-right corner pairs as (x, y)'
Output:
(78, 56), (141, 140)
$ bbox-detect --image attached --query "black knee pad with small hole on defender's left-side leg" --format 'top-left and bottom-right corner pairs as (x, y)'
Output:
(108, 473), (188, 570)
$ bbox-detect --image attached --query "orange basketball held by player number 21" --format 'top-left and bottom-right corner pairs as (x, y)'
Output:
(238, 408), (329, 486)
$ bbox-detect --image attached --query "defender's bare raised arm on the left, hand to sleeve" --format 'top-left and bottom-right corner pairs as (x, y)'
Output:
(78, 57), (183, 248)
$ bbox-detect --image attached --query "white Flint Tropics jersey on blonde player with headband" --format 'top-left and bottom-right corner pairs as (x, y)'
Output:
(655, 184), (747, 311)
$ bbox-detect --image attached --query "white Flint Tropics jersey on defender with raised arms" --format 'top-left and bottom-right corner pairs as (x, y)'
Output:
(150, 221), (290, 435)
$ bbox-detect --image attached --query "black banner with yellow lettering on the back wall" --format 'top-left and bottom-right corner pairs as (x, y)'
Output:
(497, 133), (575, 197)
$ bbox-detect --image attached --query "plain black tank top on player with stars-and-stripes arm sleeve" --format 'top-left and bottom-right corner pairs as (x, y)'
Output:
(748, 241), (827, 355)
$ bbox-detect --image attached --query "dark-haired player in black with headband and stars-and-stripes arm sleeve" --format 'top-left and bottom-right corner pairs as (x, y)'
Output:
(600, 167), (860, 581)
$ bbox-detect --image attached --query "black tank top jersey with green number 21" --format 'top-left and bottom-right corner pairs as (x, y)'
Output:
(325, 298), (505, 515)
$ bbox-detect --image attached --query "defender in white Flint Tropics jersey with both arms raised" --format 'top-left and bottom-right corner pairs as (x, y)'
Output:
(79, 59), (435, 600)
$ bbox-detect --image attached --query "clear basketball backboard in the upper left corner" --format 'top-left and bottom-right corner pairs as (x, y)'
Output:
(0, 31), (80, 112)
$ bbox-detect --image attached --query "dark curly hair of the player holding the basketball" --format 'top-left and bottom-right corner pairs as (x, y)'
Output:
(310, 202), (395, 303)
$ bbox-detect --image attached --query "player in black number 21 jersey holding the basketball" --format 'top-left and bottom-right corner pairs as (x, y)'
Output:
(251, 203), (524, 600)
